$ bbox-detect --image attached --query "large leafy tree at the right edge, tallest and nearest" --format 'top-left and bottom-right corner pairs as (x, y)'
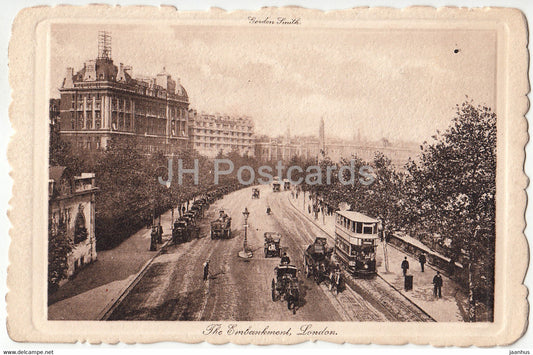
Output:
(407, 101), (496, 321)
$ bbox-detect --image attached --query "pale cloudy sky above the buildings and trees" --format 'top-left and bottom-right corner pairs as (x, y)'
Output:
(50, 24), (497, 143)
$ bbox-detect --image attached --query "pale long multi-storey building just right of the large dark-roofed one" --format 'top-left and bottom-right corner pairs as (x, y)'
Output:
(189, 110), (255, 158)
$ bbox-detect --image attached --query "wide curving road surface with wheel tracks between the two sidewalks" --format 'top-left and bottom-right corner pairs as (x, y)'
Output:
(109, 186), (431, 321)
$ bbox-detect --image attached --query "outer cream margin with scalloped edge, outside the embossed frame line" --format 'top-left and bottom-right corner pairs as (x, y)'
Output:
(6, 5), (529, 346)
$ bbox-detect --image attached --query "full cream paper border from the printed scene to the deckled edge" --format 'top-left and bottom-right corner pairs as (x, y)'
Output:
(7, 5), (529, 346)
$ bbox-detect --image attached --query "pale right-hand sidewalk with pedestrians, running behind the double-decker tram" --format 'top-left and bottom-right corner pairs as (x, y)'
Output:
(288, 194), (468, 322)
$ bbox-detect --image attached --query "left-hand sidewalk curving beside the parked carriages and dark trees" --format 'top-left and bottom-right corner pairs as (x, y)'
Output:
(48, 204), (178, 320)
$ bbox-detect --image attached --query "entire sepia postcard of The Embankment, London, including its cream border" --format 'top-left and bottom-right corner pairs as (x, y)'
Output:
(4, 2), (528, 345)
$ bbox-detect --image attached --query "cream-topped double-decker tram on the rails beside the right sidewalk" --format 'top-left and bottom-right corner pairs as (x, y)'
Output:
(335, 211), (380, 276)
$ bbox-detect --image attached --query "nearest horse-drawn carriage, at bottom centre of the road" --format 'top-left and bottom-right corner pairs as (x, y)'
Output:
(272, 265), (300, 314)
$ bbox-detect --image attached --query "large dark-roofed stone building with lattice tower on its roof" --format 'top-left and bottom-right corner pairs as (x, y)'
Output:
(59, 32), (189, 154)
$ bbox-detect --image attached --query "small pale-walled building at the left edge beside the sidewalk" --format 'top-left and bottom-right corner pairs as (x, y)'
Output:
(48, 166), (98, 284)
